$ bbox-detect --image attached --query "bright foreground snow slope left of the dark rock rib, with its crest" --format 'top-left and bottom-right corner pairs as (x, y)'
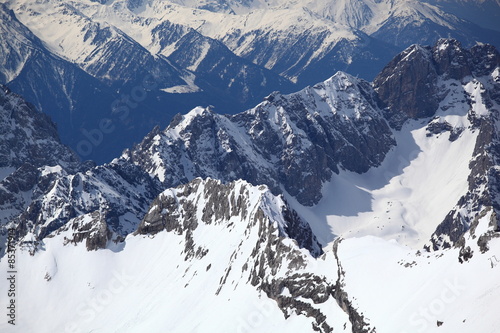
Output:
(0, 180), (348, 332)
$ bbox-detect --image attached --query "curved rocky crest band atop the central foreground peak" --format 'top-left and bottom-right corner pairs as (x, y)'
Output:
(136, 178), (322, 256)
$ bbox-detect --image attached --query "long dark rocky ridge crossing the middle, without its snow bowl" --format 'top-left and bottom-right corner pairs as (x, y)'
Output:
(0, 40), (499, 256)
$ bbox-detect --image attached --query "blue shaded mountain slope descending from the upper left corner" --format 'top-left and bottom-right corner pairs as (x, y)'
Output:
(0, 4), (129, 162)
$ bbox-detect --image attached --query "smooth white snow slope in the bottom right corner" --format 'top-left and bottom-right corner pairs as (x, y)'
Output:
(339, 217), (500, 333)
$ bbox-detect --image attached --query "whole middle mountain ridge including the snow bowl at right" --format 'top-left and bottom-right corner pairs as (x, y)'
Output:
(5, 36), (500, 255)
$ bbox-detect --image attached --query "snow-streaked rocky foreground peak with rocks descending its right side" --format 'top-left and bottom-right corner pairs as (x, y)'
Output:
(137, 178), (346, 333)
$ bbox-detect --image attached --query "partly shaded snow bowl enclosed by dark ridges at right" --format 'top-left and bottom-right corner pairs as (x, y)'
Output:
(290, 114), (477, 248)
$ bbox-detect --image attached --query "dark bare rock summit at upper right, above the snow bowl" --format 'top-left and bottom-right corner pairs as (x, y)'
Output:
(373, 39), (500, 130)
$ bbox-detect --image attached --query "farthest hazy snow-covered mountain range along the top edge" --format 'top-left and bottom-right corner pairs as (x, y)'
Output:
(53, 0), (499, 84)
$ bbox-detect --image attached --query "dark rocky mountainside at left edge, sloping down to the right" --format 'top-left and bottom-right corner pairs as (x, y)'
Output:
(0, 86), (79, 244)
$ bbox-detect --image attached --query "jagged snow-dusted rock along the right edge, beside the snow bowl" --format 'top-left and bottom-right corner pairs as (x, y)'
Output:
(427, 41), (500, 251)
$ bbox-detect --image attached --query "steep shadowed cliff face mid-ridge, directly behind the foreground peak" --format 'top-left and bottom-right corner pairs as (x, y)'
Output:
(123, 73), (394, 205)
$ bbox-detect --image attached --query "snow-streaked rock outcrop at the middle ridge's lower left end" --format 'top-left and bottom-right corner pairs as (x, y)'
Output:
(13, 161), (160, 248)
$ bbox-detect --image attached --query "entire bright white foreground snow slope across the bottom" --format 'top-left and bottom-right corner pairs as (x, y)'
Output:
(0, 191), (500, 333)
